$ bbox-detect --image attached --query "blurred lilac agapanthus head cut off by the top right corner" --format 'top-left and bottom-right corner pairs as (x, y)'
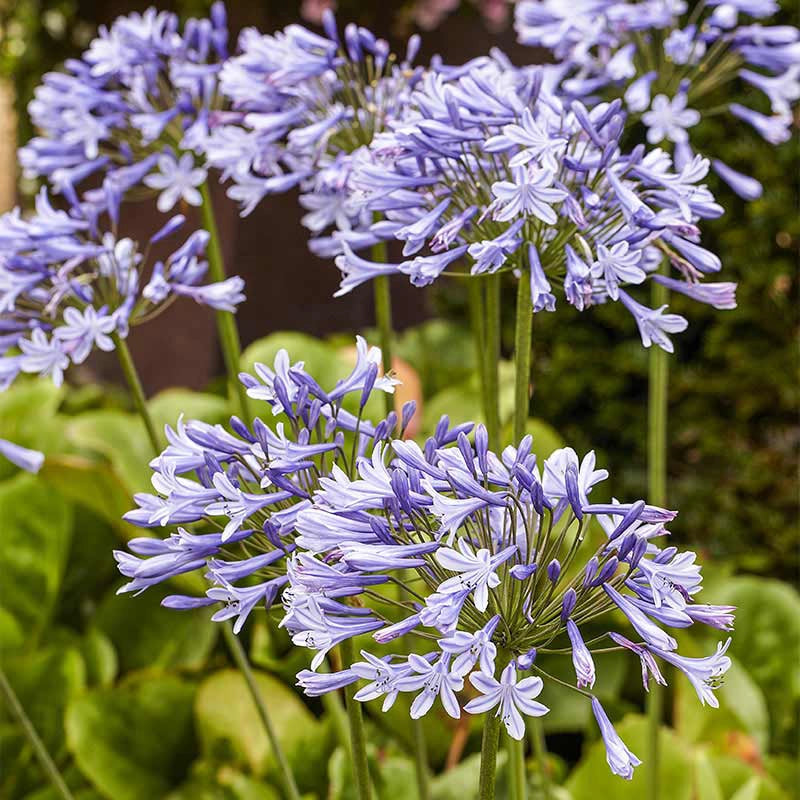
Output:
(515, 0), (800, 200)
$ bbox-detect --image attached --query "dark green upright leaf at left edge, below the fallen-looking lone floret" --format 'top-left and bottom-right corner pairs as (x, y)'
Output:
(0, 474), (72, 637)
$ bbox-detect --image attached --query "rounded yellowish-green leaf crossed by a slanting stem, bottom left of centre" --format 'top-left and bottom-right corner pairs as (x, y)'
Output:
(195, 669), (327, 789)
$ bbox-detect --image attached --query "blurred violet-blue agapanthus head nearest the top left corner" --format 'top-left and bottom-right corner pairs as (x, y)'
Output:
(19, 2), (228, 213)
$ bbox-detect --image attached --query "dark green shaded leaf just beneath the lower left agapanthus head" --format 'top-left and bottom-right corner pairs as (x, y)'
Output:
(94, 586), (218, 672)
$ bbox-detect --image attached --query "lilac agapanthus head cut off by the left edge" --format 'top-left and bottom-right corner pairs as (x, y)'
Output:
(0, 189), (244, 390)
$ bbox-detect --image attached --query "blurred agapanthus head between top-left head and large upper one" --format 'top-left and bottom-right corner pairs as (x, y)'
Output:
(205, 10), (419, 234)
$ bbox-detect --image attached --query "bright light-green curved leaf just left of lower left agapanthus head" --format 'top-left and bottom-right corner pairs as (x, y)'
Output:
(64, 410), (154, 495)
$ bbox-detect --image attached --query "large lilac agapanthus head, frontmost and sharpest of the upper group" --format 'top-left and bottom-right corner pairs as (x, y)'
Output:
(334, 54), (722, 349)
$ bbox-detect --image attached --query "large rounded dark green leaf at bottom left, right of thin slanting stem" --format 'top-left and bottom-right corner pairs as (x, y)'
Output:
(66, 677), (195, 800)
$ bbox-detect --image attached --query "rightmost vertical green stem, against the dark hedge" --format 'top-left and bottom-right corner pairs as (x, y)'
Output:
(647, 272), (669, 800)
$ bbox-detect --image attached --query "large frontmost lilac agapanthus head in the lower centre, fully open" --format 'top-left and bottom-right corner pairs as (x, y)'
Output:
(281, 423), (731, 778)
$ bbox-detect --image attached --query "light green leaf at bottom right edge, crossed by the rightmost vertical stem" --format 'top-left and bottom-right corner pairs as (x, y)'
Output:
(566, 715), (692, 800)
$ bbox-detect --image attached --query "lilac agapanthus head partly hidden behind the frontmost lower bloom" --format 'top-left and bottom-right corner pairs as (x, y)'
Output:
(115, 339), (404, 636)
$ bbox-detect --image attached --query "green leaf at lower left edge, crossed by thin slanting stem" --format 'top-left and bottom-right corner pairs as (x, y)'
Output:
(3, 646), (86, 757)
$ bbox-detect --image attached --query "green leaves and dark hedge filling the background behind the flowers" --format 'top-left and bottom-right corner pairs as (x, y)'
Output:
(0, 0), (800, 800)
